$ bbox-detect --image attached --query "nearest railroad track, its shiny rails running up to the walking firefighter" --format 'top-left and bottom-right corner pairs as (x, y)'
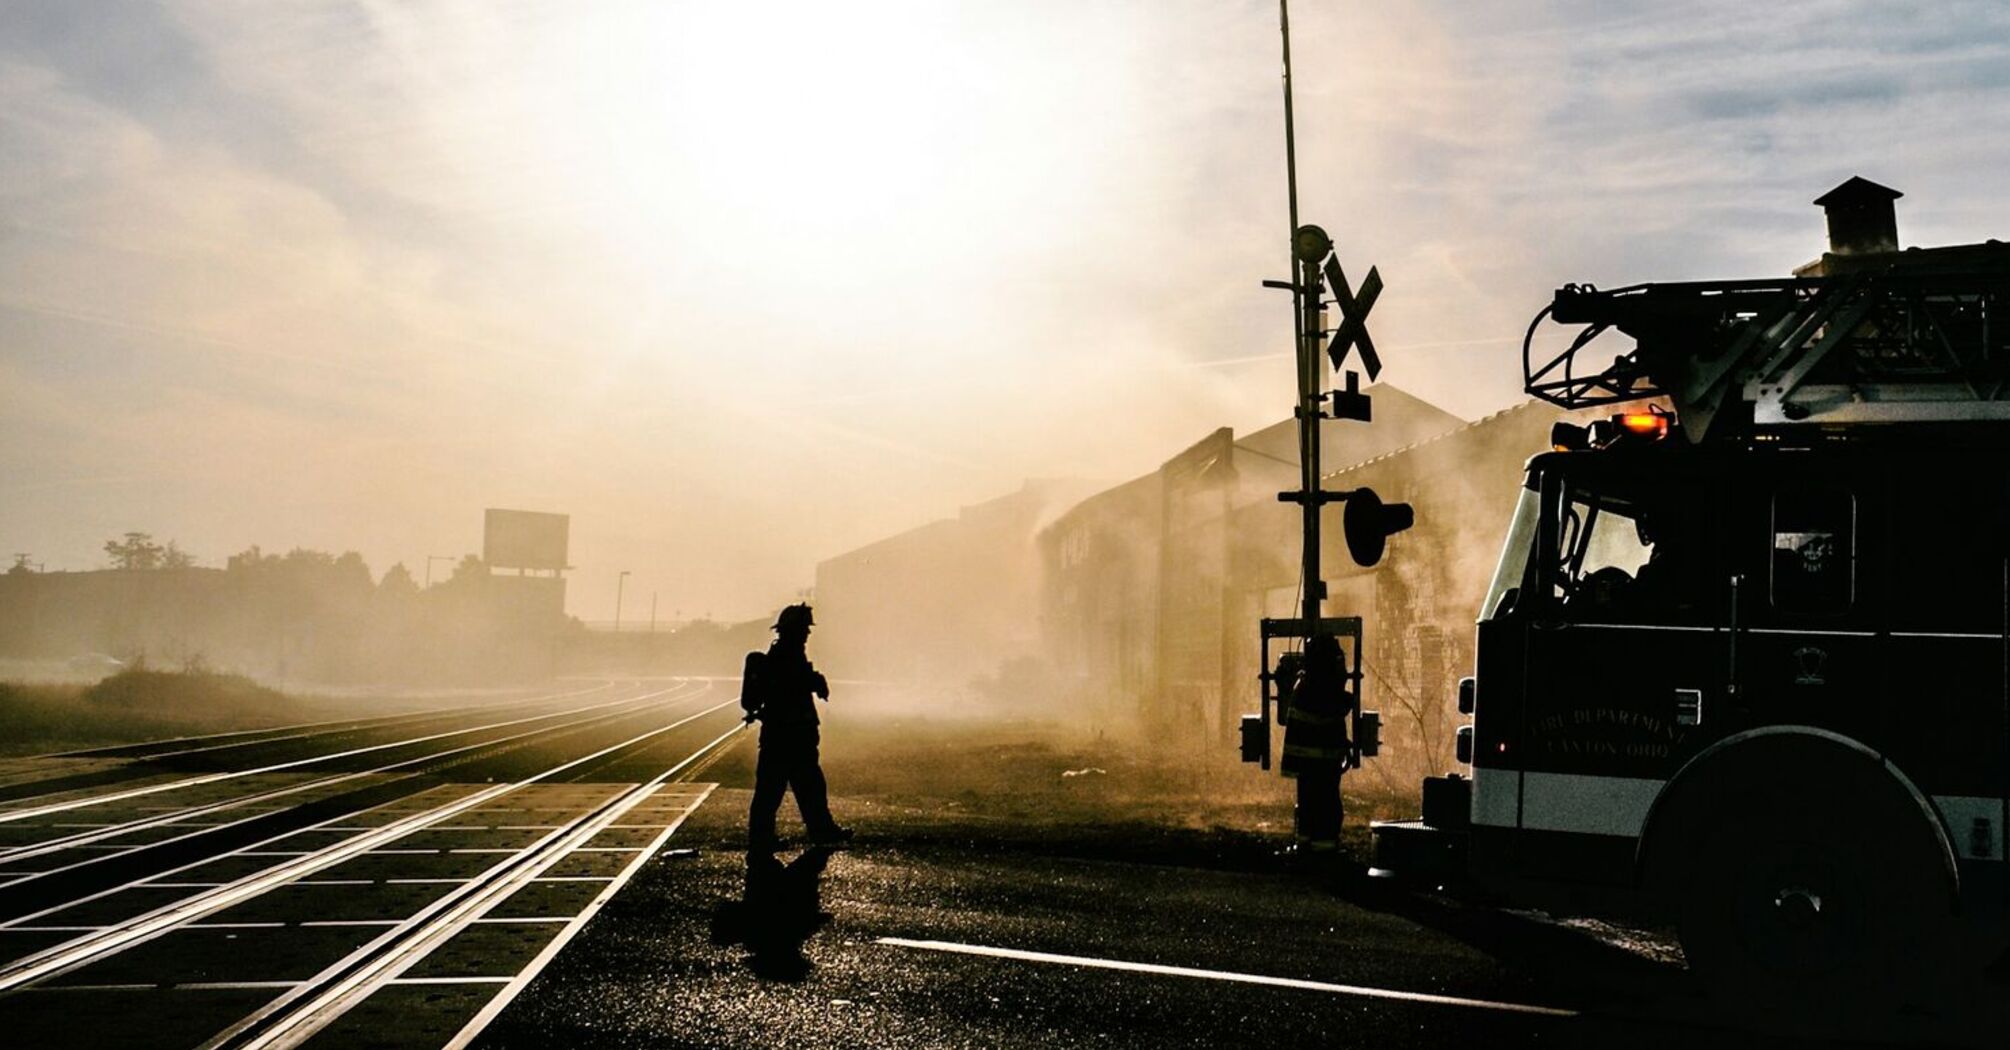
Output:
(0, 684), (740, 1046)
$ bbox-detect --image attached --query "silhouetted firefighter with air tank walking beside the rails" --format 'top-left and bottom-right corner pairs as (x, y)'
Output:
(740, 605), (852, 853)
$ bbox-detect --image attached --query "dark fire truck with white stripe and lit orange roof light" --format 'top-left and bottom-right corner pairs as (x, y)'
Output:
(1373, 179), (2010, 1002)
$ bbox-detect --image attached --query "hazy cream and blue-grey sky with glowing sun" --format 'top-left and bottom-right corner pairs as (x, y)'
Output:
(0, 0), (2010, 620)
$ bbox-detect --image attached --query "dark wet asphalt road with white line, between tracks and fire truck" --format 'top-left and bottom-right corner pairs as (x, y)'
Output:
(474, 776), (2000, 1050)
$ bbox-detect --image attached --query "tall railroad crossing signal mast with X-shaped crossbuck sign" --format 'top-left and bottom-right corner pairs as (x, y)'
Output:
(1242, 0), (1415, 768)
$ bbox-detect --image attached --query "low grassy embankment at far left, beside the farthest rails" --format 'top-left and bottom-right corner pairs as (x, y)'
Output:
(0, 670), (322, 754)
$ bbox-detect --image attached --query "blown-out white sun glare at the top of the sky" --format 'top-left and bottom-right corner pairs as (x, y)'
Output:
(478, 0), (1110, 300)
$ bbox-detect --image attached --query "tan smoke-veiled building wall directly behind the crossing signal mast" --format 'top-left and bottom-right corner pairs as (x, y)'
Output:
(1041, 396), (1591, 768)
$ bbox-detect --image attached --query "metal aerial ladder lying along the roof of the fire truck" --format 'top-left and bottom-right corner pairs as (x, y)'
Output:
(1522, 261), (2010, 441)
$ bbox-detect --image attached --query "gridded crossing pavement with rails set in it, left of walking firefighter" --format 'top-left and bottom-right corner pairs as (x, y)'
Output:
(0, 782), (712, 1048)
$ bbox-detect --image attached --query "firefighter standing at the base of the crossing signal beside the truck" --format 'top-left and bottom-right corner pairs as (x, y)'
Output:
(1280, 634), (1355, 853)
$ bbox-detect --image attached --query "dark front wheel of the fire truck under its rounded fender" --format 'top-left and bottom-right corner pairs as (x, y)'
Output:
(1668, 756), (1958, 1022)
